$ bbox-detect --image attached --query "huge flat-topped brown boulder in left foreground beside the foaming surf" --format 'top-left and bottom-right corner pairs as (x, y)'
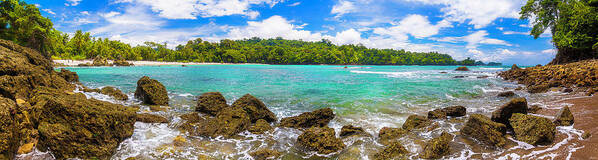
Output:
(32, 93), (136, 159)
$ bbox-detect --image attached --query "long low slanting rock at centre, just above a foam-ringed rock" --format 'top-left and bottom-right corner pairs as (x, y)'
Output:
(279, 108), (334, 128)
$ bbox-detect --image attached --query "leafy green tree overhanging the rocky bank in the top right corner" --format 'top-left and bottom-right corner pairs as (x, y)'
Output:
(521, 0), (598, 64)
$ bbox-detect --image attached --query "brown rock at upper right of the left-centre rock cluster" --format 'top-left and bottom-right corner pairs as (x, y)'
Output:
(232, 94), (276, 122)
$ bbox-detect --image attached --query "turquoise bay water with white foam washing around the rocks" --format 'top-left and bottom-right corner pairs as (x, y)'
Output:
(51, 65), (580, 159)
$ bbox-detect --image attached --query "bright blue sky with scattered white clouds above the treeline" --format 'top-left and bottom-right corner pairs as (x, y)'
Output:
(30, 0), (556, 65)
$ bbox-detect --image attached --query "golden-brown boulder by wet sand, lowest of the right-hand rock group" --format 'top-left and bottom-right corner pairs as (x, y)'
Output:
(509, 113), (556, 145)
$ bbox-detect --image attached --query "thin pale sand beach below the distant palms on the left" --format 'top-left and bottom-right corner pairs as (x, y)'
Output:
(53, 60), (264, 66)
